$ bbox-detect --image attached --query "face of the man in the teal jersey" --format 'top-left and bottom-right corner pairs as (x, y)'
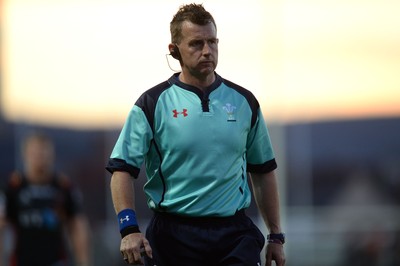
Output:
(178, 21), (218, 79)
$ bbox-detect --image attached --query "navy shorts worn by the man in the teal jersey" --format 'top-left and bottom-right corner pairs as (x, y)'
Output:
(145, 211), (265, 266)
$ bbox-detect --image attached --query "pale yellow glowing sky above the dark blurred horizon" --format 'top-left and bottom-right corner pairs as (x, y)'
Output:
(0, 0), (400, 127)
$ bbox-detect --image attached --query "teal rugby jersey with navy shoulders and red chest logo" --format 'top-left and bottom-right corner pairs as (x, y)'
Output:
(106, 74), (276, 216)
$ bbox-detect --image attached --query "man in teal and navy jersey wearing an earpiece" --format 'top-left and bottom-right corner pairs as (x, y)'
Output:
(106, 4), (285, 266)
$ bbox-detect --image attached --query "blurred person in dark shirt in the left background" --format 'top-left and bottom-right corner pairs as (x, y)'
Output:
(0, 132), (91, 266)
